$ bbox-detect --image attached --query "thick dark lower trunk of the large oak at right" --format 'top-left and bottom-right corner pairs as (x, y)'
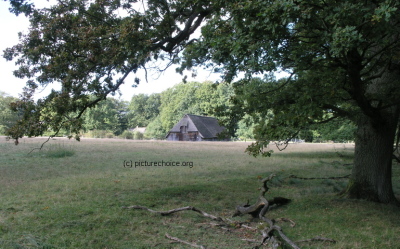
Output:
(345, 108), (398, 205)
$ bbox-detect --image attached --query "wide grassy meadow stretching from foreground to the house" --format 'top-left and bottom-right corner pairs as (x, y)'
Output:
(0, 137), (400, 249)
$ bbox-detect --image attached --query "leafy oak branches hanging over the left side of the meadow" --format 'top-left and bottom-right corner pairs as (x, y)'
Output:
(3, 0), (214, 139)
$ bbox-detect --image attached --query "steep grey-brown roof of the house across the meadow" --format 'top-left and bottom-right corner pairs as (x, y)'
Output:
(170, 114), (225, 138)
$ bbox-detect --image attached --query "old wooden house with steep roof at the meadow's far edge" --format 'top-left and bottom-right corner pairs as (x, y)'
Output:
(166, 114), (227, 141)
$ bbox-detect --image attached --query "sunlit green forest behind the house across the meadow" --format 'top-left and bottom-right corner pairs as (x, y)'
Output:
(0, 82), (355, 142)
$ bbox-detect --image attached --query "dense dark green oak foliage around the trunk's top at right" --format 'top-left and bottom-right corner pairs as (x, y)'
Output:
(181, 1), (400, 158)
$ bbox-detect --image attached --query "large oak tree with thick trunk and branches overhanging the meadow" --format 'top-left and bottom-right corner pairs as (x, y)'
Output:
(4, 0), (400, 203)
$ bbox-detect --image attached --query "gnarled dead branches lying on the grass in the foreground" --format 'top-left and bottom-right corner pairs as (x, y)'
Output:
(123, 174), (335, 249)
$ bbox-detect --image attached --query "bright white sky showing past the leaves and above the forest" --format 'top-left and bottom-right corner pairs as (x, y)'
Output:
(0, 0), (220, 101)
